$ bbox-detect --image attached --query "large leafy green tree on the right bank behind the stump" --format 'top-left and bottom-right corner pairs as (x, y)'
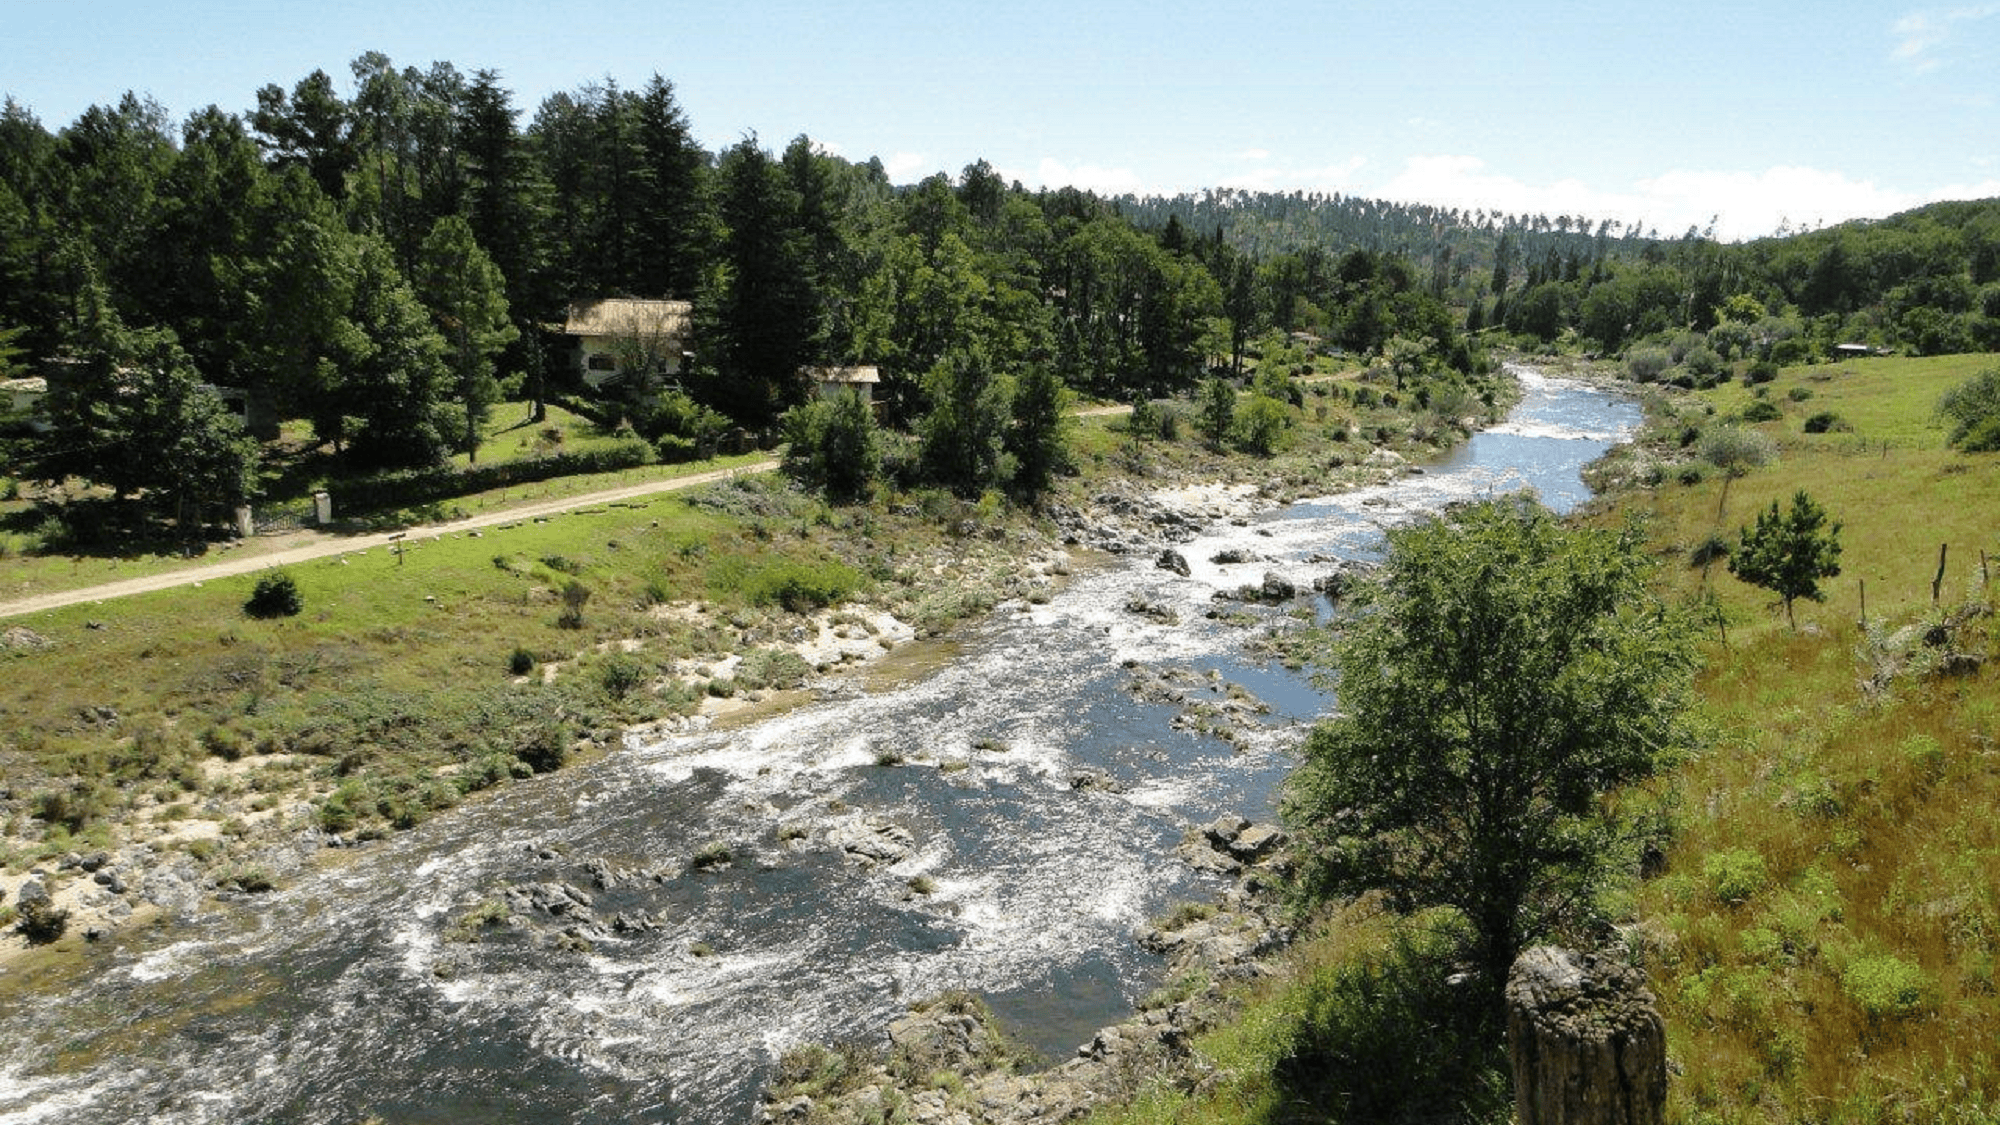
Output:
(1284, 498), (1694, 989)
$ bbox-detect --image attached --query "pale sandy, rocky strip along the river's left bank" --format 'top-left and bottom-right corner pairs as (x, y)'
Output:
(0, 366), (1476, 971)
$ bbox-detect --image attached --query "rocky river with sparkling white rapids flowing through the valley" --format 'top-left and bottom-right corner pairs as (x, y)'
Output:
(0, 370), (1638, 1125)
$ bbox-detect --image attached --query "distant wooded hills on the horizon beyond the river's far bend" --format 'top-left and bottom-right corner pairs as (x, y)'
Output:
(1116, 190), (2000, 356)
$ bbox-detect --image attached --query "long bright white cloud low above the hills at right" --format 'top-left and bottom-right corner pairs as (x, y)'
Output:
(1368, 156), (2000, 240)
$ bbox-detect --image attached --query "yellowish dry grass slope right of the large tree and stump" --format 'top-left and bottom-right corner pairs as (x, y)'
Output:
(1620, 348), (2000, 1123)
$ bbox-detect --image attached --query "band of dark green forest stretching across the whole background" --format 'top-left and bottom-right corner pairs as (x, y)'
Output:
(0, 54), (2000, 540)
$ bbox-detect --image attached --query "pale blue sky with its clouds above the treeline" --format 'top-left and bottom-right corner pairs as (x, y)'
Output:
(0, 0), (2000, 238)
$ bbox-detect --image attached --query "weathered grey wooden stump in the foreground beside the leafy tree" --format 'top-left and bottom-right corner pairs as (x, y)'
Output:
(1506, 945), (1666, 1125)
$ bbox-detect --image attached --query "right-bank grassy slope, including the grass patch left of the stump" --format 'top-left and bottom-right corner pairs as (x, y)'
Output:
(1092, 356), (2000, 1125)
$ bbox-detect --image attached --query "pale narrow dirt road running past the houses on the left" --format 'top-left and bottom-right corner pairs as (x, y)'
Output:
(0, 460), (778, 617)
